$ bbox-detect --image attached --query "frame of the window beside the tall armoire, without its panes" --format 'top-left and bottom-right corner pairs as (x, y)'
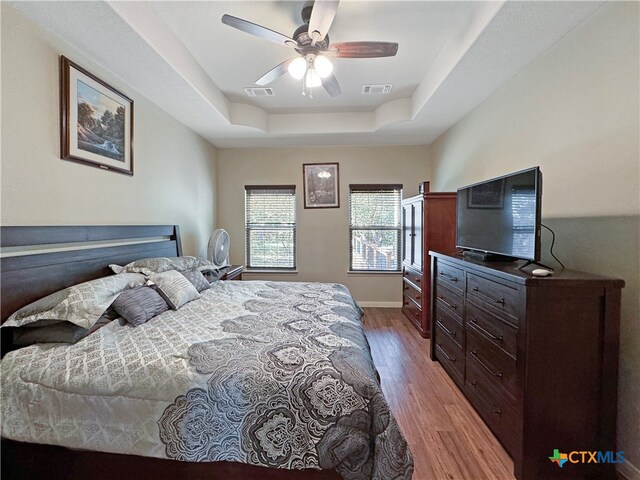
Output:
(348, 183), (403, 275)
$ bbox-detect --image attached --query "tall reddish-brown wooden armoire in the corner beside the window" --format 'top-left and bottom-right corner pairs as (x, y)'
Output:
(402, 182), (456, 338)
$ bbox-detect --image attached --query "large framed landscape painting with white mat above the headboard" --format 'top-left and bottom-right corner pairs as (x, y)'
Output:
(60, 57), (133, 175)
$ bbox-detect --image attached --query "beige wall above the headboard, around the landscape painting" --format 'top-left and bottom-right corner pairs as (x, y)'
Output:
(0, 4), (217, 255)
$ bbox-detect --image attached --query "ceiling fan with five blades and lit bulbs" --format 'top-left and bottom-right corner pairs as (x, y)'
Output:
(222, 0), (398, 98)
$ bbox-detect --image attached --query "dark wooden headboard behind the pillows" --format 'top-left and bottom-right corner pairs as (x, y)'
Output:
(0, 225), (182, 322)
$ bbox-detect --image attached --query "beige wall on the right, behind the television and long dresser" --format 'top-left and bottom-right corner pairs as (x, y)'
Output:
(431, 2), (640, 474)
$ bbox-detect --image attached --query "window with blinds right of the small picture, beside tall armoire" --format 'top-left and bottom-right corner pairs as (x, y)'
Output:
(349, 185), (402, 272)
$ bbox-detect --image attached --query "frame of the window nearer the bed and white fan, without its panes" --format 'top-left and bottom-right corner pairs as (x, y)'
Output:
(244, 185), (298, 273)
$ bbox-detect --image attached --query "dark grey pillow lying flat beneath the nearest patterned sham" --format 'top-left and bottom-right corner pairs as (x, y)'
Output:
(9, 316), (112, 347)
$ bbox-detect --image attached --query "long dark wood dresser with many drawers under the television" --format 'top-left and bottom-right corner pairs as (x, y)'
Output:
(429, 252), (624, 480)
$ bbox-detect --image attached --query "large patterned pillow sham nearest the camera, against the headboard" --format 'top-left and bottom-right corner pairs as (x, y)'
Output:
(3, 273), (145, 329)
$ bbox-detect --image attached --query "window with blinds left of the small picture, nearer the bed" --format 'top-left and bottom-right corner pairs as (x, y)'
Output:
(245, 185), (296, 270)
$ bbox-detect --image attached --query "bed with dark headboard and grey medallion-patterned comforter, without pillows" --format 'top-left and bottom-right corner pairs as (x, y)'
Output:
(1, 225), (413, 480)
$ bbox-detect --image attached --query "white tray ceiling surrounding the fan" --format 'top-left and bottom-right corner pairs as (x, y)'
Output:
(11, 0), (603, 147)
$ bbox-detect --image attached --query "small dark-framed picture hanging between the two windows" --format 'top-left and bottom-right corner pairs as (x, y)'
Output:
(302, 163), (340, 208)
